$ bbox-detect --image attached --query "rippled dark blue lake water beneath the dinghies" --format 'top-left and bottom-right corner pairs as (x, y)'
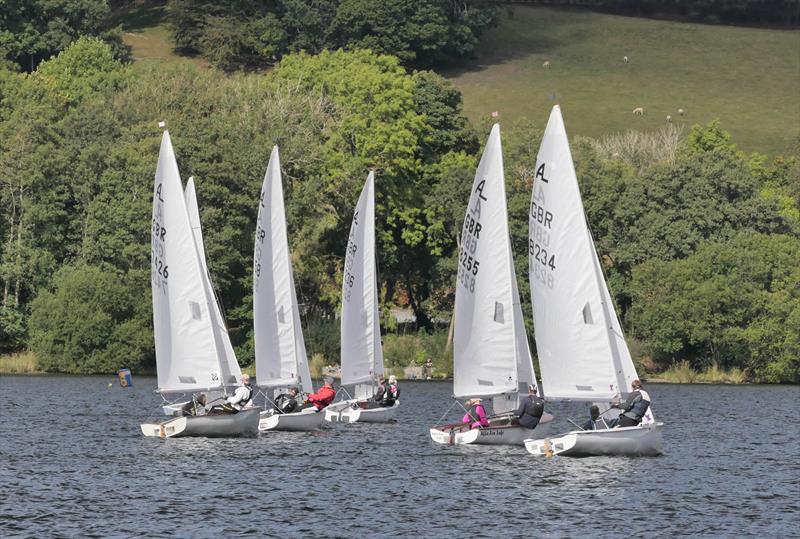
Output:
(0, 376), (800, 539)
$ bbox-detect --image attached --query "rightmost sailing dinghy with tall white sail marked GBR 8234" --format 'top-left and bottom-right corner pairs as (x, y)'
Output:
(525, 105), (663, 456)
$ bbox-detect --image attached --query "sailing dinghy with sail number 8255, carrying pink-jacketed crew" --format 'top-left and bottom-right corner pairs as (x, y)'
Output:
(430, 124), (552, 445)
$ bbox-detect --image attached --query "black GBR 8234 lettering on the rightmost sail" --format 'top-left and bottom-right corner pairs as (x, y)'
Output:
(528, 162), (558, 288)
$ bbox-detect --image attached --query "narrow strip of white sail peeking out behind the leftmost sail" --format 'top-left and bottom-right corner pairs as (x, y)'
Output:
(184, 177), (242, 385)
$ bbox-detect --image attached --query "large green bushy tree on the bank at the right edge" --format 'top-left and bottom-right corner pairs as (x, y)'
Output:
(630, 232), (800, 382)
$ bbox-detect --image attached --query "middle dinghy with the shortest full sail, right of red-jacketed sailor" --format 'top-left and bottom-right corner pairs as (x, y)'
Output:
(325, 172), (400, 423)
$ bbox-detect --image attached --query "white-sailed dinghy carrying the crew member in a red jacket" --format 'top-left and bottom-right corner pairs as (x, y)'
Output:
(253, 146), (324, 431)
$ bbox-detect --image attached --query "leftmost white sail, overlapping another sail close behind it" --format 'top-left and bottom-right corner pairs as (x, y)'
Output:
(151, 131), (237, 393)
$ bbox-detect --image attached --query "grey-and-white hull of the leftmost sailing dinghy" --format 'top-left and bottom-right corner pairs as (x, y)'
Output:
(141, 408), (261, 438)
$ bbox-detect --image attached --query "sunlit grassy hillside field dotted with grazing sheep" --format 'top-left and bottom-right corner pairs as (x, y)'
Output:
(445, 6), (800, 155)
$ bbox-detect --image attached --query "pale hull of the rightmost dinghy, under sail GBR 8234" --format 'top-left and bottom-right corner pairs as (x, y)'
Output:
(525, 423), (664, 457)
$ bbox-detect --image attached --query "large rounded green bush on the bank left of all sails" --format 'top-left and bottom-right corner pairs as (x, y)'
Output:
(30, 265), (152, 373)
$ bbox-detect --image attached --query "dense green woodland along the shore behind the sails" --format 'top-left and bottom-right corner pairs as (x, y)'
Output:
(0, 2), (800, 382)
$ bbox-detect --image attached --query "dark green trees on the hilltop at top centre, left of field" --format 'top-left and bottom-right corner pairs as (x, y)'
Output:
(168, 0), (497, 70)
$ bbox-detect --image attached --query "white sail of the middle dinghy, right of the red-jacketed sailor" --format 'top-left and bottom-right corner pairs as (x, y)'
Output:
(341, 172), (383, 385)
